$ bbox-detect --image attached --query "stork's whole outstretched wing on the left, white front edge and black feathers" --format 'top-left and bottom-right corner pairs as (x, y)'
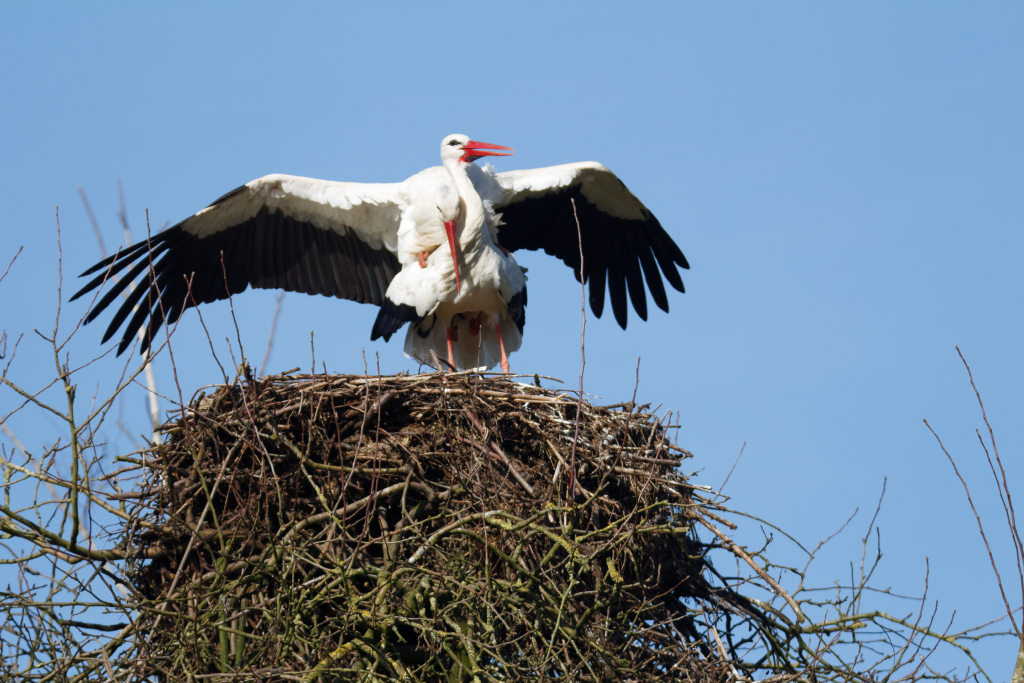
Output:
(72, 175), (403, 355)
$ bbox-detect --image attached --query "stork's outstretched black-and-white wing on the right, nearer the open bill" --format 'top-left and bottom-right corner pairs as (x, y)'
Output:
(473, 162), (690, 329)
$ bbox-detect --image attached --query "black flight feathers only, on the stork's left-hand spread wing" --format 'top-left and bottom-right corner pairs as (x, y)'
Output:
(72, 204), (400, 355)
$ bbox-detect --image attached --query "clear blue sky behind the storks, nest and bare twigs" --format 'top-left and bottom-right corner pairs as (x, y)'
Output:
(0, 2), (1024, 680)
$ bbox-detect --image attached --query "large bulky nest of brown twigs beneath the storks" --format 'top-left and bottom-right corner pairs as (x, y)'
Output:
(123, 374), (765, 682)
